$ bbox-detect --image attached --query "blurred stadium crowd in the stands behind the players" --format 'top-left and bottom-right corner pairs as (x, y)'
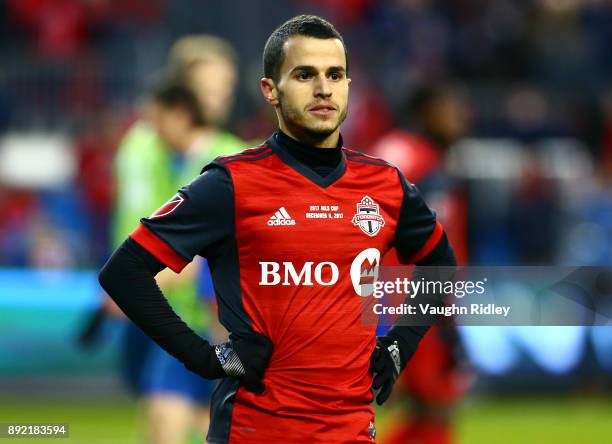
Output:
(0, 0), (612, 267)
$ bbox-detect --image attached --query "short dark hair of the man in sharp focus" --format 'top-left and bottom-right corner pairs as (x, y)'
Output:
(263, 15), (348, 81)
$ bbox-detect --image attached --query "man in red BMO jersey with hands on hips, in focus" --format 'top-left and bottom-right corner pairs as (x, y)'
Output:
(100, 16), (455, 443)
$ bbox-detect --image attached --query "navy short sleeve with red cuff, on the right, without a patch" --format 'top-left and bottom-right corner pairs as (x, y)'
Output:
(392, 171), (444, 264)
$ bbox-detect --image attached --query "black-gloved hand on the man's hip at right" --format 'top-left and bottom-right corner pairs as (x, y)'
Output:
(370, 336), (401, 405)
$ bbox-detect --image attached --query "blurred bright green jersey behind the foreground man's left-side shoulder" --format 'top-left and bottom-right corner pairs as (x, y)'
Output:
(111, 121), (244, 329)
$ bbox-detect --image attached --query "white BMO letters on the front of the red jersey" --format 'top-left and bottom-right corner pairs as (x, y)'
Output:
(259, 262), (340, 286)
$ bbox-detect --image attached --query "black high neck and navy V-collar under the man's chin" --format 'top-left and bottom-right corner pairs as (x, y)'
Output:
(268, 130), (346, 188)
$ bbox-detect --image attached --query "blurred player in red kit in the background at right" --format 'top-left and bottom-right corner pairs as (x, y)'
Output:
(373, 85), (470, 444)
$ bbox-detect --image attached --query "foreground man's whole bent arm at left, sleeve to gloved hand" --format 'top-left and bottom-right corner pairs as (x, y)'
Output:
(99, 167), (272, 392)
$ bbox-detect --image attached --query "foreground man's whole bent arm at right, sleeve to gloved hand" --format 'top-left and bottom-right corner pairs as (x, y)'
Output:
(370, 171), (457, 405)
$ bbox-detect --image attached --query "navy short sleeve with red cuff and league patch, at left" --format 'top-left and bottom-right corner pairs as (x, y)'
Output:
(130, 164), (234, 273)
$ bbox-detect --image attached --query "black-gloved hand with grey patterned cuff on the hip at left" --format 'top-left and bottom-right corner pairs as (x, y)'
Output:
(215, 332), (273, 394)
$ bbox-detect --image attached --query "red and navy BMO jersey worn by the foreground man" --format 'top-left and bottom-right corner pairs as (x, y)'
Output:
(131, 133), (442, 443)
